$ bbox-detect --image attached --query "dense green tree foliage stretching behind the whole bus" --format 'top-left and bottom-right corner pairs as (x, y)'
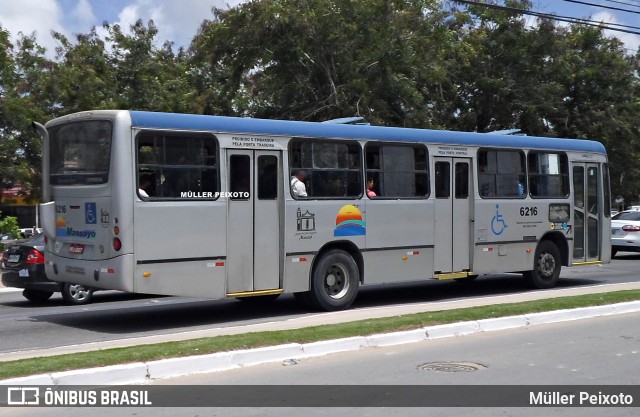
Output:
(0, 0), (640, 201)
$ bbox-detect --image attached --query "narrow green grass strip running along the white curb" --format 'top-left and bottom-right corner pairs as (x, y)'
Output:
(0, 290), (640, 379)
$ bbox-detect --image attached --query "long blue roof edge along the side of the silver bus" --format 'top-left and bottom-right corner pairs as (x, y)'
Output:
(130, 111), (606, 154)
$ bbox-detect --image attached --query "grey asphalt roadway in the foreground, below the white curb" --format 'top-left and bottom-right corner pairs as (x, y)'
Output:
(3, 313), (640, 417)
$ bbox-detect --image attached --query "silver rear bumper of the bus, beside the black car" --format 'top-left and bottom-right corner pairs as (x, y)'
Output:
(45, 252), (134, 292)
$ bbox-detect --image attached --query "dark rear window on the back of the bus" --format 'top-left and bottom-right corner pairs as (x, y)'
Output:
(49, 120), (111, 185)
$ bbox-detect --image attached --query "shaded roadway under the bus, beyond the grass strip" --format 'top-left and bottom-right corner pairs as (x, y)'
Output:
(0, 255), (640, 360)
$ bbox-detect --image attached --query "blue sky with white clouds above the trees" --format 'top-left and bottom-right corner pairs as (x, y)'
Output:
(0, 0), (640, 53)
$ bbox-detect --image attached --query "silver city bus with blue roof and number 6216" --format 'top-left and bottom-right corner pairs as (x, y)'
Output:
(36, 111), (611, 310)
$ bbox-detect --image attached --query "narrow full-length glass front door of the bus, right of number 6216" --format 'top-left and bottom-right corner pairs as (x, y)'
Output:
(573, 162), (602, 263)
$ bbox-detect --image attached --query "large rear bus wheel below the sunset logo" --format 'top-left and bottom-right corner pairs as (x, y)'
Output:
(309, 249), (360, 311)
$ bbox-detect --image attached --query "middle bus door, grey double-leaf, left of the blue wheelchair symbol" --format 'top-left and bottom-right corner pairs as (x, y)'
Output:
(434, 157), (473, 279)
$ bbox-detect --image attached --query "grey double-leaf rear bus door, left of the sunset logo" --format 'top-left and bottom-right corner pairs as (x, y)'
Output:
(226, 149), (282, 297)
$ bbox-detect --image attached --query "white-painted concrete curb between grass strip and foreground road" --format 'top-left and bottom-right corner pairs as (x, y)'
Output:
(0, 301), (640, 385)
